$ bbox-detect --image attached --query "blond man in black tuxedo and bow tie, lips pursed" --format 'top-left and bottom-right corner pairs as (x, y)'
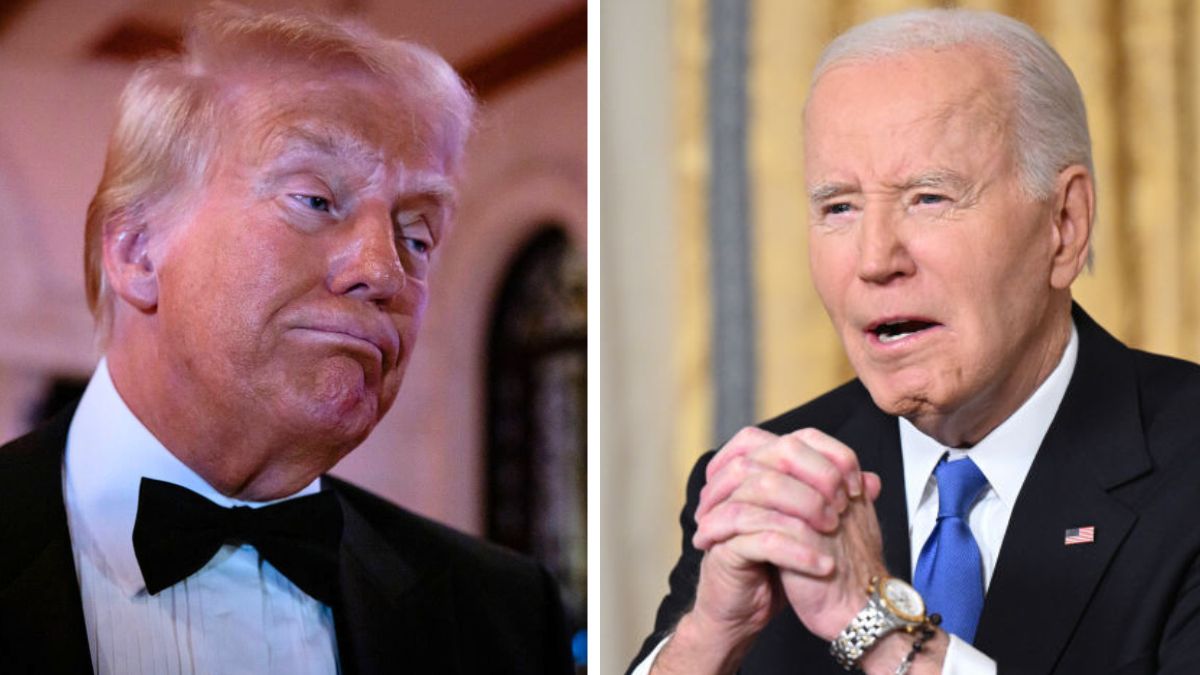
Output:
(0, 6), (571, 674)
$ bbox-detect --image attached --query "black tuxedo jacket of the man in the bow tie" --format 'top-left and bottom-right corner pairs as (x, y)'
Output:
(0, 403), (572, 675)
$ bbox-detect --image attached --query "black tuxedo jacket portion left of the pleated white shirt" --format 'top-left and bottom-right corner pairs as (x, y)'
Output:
(0, 406), (91, 673)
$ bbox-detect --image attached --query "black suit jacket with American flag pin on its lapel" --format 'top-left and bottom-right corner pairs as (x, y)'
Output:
(634, 306), (1200, 675)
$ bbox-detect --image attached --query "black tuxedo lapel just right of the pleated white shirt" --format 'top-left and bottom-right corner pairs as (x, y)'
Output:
(334, 485), (469, 675)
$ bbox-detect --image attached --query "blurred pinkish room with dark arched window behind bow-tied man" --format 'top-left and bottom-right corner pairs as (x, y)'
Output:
(0, 0), (587, 662)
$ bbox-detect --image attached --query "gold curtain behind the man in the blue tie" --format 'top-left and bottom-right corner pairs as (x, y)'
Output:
(672, 0), (1200, 478)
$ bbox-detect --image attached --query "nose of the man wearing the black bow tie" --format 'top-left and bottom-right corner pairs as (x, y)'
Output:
(329, 204), (408, 306)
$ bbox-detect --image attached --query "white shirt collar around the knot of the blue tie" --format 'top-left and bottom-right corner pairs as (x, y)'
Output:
(900, 322), (1079, 519)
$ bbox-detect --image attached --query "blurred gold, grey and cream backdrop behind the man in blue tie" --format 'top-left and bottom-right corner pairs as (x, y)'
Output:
(604, 0), (1200, 673)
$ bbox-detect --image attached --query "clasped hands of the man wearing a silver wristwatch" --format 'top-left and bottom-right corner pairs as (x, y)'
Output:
(692, 428), (886, 640)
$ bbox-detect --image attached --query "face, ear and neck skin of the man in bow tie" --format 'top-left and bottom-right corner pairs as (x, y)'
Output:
(106, 73), (450, 500)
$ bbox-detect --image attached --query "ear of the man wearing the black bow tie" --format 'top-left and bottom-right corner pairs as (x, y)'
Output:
(103, 209), (158, 312)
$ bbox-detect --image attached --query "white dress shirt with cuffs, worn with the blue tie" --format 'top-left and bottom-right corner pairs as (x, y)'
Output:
(632, 324), (1079, 675)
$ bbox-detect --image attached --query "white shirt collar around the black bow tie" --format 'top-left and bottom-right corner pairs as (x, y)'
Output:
(62, 359), (320, 597)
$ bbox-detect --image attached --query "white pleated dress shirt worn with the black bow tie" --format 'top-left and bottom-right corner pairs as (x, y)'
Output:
(62, 360), (338, 675)
